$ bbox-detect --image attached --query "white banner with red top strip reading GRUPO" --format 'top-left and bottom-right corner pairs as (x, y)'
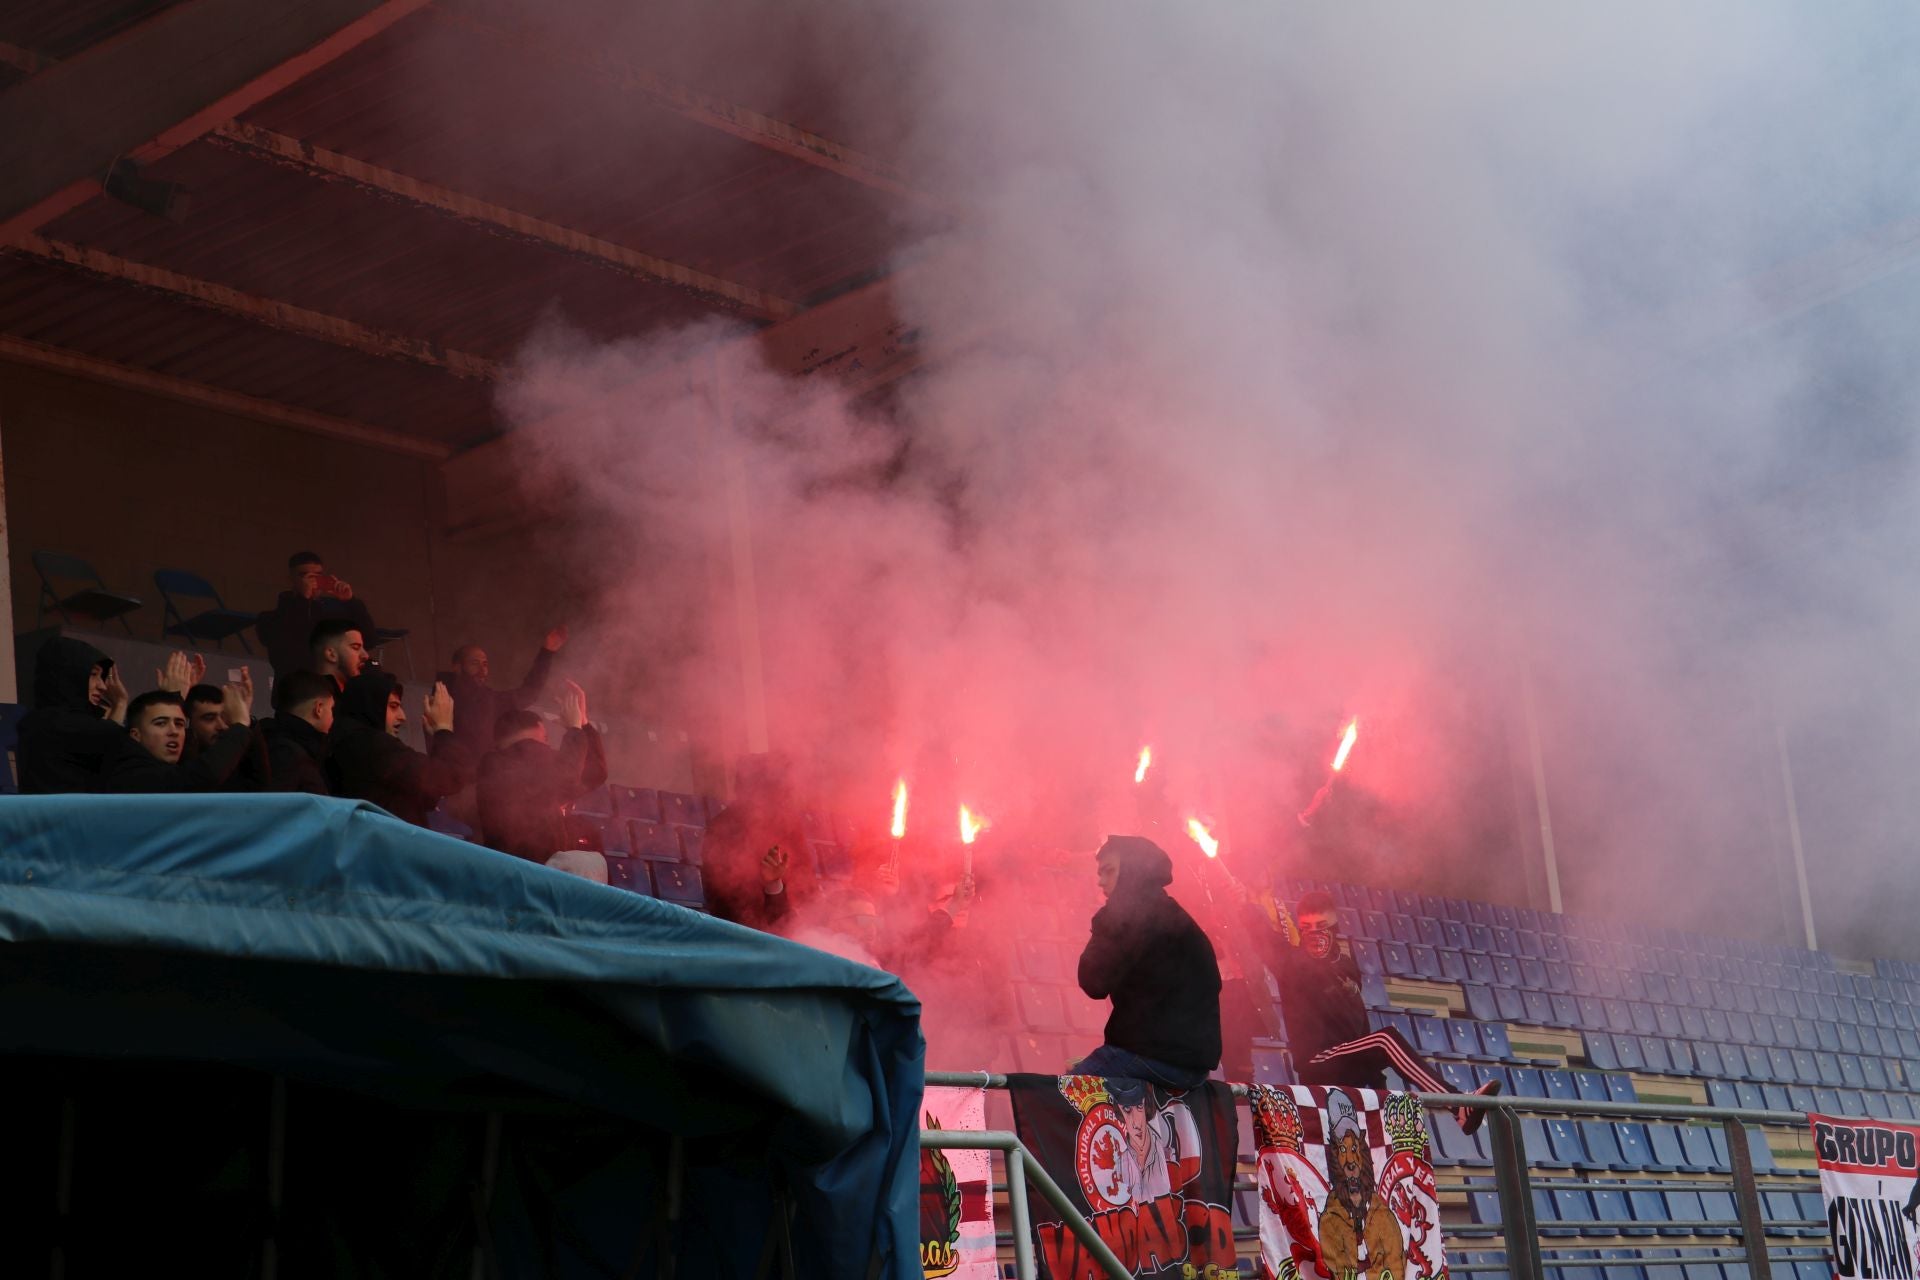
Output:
(1807, 1115), (1920, 1280)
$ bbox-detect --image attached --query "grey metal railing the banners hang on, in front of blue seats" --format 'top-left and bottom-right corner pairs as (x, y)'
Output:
(920, 1071), (1807, 1280)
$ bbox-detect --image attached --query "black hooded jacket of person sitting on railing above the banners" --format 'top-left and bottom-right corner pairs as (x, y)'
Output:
(1079, 835), (1221, 1071)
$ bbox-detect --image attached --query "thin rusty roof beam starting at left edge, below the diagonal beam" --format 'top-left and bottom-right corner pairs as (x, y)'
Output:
(12, 234), (501, 380)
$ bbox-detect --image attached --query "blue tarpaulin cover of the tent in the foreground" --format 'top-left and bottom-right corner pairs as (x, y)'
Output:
(0, 794), (924, 1278)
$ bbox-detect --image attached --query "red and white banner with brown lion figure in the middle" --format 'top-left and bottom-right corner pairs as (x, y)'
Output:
(1248, 1084), (1448, 1280)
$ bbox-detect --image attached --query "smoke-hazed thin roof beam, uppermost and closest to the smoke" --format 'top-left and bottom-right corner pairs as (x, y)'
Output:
(432, 4), (947, 209)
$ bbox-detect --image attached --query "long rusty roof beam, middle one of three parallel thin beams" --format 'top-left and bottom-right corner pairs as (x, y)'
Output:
(207, 121), (801, 320)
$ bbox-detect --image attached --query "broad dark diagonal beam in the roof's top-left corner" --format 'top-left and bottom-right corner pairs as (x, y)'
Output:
(0, 0), (426, 246)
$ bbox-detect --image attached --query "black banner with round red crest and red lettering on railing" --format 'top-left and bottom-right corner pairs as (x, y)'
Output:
(1008, 1075), (1238, 1280)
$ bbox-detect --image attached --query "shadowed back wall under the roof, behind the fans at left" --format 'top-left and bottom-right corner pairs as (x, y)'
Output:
(0, 365), (442, 677)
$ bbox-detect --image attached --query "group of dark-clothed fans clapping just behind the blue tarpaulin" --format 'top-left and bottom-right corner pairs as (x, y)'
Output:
(17, 551), (607, 875)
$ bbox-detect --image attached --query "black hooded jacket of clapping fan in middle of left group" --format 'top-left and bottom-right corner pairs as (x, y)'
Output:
(326, 672), (470, 827)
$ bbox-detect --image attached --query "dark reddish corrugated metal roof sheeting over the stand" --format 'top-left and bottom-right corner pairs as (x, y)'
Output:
(0, 0), (924, 447)
